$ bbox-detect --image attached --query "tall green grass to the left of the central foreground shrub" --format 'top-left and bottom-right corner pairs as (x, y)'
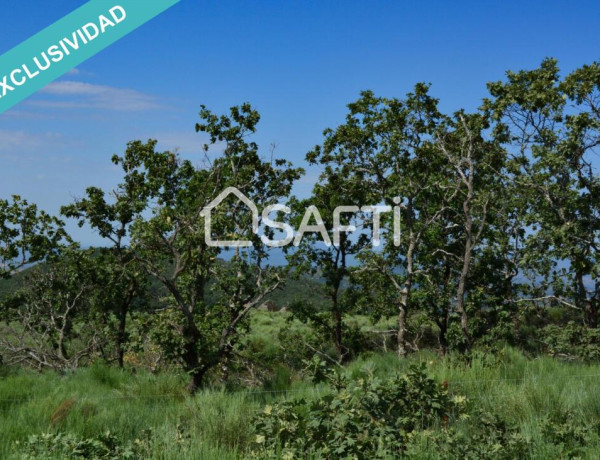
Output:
(0, 358), (328, 459)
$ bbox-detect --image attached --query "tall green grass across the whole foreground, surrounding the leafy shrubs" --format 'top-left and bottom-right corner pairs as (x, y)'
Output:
(0, 349), (600, 459)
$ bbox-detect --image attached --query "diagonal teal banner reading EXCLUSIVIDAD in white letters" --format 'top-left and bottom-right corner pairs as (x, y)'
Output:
(0, 0), (180, 113)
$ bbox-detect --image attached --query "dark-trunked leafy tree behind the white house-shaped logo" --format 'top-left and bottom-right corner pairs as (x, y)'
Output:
(108, 104), (301, 391)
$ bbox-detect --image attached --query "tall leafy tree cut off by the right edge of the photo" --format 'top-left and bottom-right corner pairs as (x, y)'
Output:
(485, 59), (600, 327)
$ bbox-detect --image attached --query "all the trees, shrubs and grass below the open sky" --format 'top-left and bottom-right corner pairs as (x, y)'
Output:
(0, 59), (600, 459)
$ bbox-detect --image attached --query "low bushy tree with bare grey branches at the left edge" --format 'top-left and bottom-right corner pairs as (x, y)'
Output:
(0, 248), (103, 370)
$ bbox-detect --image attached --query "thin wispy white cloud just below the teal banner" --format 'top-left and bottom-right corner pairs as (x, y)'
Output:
(28, 80), (164, 111)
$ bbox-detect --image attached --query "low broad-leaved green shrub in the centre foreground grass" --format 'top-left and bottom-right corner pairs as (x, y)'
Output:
(253, 363), (454, 459)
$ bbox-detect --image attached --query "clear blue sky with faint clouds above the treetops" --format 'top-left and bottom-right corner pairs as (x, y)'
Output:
(0, 0), (600, 248)
